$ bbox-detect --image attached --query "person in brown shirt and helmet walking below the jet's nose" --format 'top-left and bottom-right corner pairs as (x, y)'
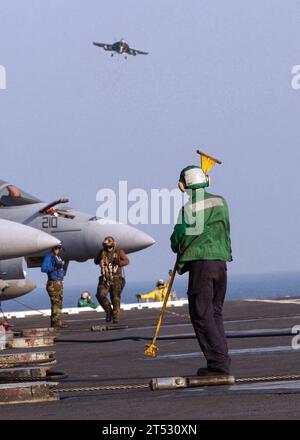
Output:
(94, 237), (129, 324)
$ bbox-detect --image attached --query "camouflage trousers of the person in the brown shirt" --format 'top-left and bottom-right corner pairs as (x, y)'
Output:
(96, 276), (125, 321)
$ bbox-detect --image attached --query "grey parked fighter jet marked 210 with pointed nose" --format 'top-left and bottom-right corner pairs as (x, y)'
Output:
(0, 180), (155, 299)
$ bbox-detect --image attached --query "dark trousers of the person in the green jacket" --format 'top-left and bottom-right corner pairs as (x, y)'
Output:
(188, 260), (230, 373)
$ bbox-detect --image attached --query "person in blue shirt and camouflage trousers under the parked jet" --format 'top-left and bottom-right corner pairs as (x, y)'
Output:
(41, 245), (66, 328)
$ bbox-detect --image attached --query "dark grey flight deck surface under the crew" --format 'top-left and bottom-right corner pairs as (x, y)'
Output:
(0, 301), (300, 420)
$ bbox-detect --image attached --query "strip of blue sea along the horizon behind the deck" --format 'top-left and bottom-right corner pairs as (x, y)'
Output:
(1, 271), (300, 312)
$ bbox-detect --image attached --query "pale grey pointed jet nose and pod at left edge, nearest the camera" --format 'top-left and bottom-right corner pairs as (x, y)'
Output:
(0, 219), (60, 302)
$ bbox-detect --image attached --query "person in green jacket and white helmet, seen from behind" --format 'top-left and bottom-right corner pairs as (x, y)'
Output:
(171, 165), (232, 375)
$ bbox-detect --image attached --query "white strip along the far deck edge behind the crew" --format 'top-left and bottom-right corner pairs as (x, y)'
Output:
(4, 299), (188, 319)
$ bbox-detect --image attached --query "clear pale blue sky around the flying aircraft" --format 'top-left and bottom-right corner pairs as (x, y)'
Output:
(0, 0), (300, 290)
